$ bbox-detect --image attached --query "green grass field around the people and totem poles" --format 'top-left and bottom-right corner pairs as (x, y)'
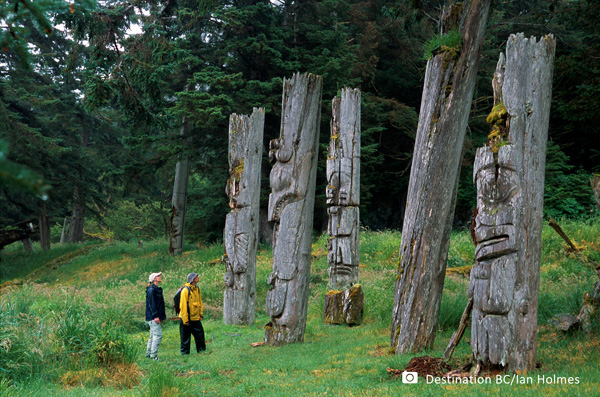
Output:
(0, 218), (600, 396)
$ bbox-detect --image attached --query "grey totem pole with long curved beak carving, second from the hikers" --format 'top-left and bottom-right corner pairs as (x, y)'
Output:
(265, 73), (322, 345)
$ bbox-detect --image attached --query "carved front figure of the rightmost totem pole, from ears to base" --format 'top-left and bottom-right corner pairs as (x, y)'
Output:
(469, 145), (523, 364)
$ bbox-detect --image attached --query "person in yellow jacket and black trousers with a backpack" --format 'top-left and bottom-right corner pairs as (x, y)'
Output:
(179, 273), (206, 355)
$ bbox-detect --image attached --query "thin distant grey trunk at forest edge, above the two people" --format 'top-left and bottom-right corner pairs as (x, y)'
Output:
(169, 116), (192, 255)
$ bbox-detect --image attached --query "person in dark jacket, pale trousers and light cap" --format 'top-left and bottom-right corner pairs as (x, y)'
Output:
(146, 273), (167, 361)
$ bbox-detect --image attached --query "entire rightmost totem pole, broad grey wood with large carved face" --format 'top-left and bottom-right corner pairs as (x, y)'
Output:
(469, 34), (555, 371)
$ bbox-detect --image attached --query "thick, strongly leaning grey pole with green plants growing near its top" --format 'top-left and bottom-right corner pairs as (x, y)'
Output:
(391, 0), (491, 354)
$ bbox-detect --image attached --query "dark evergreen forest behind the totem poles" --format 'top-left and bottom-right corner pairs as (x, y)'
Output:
(0, 0), (600, 244)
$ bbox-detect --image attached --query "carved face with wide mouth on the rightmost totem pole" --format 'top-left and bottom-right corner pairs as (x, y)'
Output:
(474, 145), (521, 261)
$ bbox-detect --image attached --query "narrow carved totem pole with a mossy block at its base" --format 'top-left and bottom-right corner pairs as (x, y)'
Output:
(323, 88), (364, 325)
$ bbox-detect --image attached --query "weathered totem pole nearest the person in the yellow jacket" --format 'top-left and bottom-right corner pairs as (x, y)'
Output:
(223, 108), (265, 325)
